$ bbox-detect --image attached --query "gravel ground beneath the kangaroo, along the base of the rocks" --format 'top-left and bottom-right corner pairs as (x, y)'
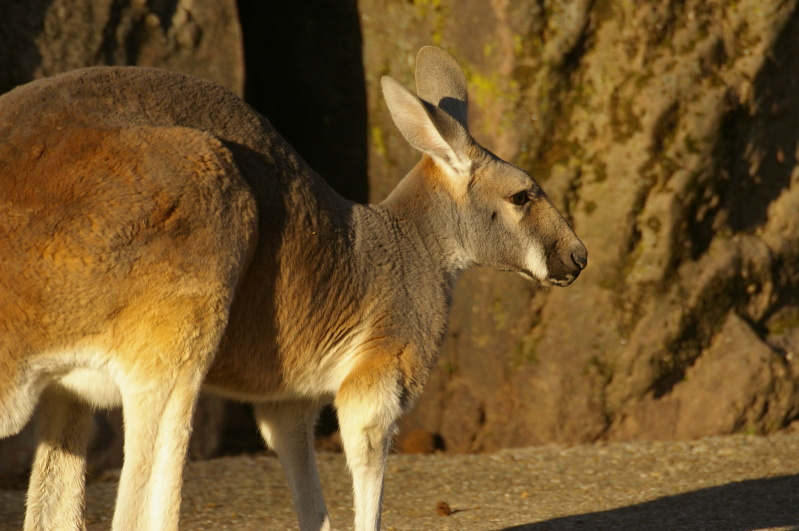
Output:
(0, 434), (799, 531)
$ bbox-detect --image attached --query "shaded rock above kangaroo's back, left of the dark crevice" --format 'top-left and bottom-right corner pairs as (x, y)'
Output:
(0, 0), (244, 94)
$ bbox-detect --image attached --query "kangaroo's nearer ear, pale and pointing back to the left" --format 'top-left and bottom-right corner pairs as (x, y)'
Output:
(381, 76), (471, 174)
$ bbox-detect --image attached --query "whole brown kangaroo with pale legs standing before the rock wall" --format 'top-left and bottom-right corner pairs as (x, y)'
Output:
(0, 47), (587, 531)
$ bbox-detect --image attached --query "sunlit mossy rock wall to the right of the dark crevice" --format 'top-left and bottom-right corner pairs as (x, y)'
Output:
(360, 0), (799, 451)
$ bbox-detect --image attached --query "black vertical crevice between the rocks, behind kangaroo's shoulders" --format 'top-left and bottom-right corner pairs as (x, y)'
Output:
(233, 0), (368, 202)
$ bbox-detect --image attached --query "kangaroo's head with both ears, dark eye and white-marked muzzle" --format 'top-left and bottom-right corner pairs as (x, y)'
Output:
(382, 46), (588, 286)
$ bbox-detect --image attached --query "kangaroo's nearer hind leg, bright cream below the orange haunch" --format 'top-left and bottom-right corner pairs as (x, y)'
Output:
(113, 298), (238, 531)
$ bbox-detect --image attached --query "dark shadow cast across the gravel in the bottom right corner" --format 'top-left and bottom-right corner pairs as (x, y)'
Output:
(504, 475), (799, 531)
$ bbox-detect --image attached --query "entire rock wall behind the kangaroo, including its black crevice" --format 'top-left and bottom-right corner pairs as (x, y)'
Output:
(0, 0), (799, 482)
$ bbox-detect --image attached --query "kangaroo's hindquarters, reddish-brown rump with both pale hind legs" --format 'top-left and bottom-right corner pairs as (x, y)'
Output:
(0, 68), (268, 529)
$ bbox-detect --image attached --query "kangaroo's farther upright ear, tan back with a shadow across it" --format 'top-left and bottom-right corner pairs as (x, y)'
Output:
(416, 46), (469, 131)
